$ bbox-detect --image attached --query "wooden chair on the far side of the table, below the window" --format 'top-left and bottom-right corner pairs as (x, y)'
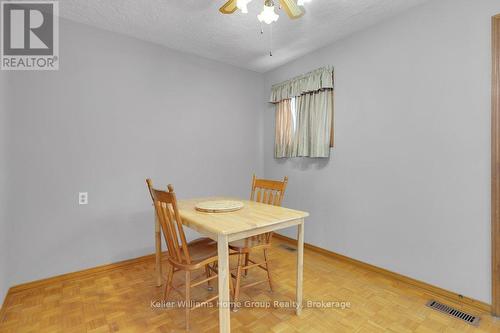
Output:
(229, 175), (288, 311)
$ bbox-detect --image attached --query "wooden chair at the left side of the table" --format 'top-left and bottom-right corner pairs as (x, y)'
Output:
(146, 179), (219, 329)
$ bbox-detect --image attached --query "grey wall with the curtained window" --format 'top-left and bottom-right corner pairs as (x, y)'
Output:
(264, 0), (500, 303)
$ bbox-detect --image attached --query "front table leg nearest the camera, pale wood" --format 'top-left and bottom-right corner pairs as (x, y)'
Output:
(217, 235), (231, 333)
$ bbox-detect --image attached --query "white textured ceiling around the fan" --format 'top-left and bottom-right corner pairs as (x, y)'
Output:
(60, 0), (428, 72)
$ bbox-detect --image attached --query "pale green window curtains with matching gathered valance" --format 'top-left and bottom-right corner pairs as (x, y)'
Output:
(270, 67), (334, 158)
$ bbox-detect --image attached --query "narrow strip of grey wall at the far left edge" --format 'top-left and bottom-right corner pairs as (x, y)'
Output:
(0, 72), (9, 307)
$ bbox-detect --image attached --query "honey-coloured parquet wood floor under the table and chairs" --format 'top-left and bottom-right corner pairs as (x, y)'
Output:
(0, 240), (500, 333)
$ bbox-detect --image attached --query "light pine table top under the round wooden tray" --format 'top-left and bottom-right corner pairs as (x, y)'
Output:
(178, 197), (309, 235)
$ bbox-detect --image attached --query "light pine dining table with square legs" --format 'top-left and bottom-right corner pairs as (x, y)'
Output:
(155, 197), (309, 333)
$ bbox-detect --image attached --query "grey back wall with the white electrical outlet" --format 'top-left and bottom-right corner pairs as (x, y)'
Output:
(7, 20), (263, 285)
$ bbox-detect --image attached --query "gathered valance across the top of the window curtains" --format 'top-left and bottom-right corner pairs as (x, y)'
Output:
(270, 67), (333, 103)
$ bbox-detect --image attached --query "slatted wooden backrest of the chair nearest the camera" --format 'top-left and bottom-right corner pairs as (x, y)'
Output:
(146, 179), (191, 264)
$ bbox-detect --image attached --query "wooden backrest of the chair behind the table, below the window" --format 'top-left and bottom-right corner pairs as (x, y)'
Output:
(250, 175), (288, 206)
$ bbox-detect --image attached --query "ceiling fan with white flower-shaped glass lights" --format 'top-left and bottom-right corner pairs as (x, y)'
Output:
(219, 0), (311, 24)
